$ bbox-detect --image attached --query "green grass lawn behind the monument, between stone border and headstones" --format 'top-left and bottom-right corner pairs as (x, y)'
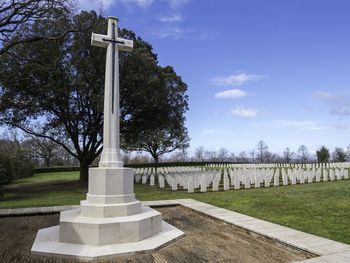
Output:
(0, 172), (350, 244)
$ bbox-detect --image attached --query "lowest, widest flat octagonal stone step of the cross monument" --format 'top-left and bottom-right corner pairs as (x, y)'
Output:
(31, 221), (184, 260)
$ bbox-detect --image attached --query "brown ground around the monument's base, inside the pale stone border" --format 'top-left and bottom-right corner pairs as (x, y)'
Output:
(0, 206), (307, 263)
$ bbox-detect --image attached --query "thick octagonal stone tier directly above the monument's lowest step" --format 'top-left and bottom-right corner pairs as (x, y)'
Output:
(59, 206), (162, 246)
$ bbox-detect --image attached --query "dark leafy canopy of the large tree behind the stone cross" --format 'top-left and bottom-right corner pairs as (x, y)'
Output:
(0, 11), (189, 181)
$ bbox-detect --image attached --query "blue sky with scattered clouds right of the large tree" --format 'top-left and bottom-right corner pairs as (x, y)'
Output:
(79, 0), (350, 153)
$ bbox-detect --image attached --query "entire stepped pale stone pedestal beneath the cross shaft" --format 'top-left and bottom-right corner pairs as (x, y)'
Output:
(31, 167), (184, 260)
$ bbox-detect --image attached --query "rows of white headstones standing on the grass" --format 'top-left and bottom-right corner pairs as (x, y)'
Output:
(135, 163), (350, 193)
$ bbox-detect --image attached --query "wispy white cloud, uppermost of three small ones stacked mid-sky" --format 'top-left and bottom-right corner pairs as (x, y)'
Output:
(210, 72), (266, 86)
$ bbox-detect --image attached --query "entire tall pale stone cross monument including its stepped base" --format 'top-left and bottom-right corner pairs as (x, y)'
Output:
(31, 17), (184, 260)
